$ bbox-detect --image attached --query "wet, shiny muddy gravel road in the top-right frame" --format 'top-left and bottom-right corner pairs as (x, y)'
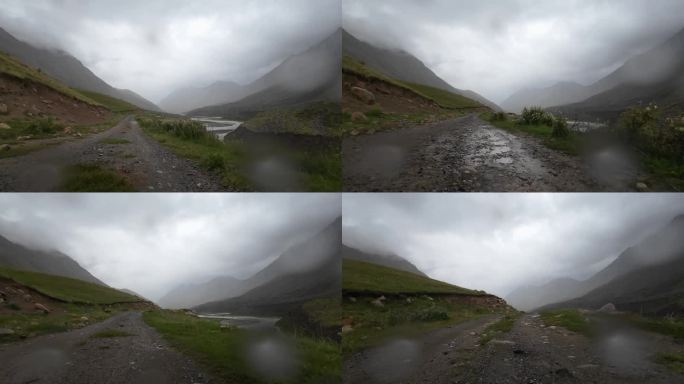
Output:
(343, 114), (626, 192)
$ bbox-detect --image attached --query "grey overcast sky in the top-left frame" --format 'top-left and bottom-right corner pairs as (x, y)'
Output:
(0, 0), (341, 102)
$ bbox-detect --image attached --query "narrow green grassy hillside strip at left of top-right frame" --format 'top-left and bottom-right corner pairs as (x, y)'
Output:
(342, 55), (482, 109)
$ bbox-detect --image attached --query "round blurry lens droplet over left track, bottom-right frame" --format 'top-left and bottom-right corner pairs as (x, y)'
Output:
(364, 340), (421, 383)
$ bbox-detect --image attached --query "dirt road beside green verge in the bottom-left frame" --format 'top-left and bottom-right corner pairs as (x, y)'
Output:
(0, 312), (213, 384)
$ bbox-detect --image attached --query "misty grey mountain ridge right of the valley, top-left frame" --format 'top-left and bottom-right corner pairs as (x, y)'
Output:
(169, 30), (342, 119)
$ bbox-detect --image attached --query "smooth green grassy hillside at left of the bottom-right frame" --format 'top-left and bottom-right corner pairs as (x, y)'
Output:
(342, 259), (485, 295)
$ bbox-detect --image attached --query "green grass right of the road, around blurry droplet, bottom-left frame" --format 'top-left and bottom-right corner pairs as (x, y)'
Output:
(143, 310), (341, 384)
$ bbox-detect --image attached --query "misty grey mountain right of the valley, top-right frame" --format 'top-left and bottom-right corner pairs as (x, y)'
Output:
(503, 29), (684, 119)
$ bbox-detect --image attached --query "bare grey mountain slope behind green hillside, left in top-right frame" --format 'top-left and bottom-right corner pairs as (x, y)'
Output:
(342, 30), (501, 111)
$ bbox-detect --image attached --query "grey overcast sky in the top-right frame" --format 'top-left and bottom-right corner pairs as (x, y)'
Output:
(342, 0), (684, 102)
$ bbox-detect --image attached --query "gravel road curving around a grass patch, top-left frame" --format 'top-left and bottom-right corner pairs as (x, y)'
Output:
(0, 116), (222, 192)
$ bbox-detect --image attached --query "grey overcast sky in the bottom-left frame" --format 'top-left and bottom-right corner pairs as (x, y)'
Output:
(0, 193), (341, 300)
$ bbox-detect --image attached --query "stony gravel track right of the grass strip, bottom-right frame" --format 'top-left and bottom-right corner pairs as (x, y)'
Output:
(450, 315), (684, 384)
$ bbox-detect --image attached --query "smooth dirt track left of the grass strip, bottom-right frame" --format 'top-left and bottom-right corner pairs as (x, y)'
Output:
(342, 316), (499, 384)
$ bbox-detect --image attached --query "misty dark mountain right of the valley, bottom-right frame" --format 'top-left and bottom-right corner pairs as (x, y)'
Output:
(506, 215), (684, 310)
